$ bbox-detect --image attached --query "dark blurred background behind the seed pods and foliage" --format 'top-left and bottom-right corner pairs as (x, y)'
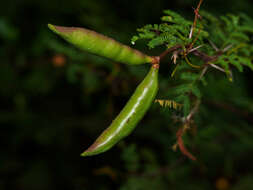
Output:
(0, 0), (253, 190)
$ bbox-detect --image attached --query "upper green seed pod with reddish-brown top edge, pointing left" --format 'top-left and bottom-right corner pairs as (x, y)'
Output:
(48, 24), (153, 65)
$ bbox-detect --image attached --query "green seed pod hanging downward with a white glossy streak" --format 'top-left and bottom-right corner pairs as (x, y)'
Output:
(81, 65), (159, 156)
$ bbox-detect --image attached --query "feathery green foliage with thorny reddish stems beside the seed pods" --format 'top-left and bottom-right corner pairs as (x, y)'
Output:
(132, 6), (253, 160)
